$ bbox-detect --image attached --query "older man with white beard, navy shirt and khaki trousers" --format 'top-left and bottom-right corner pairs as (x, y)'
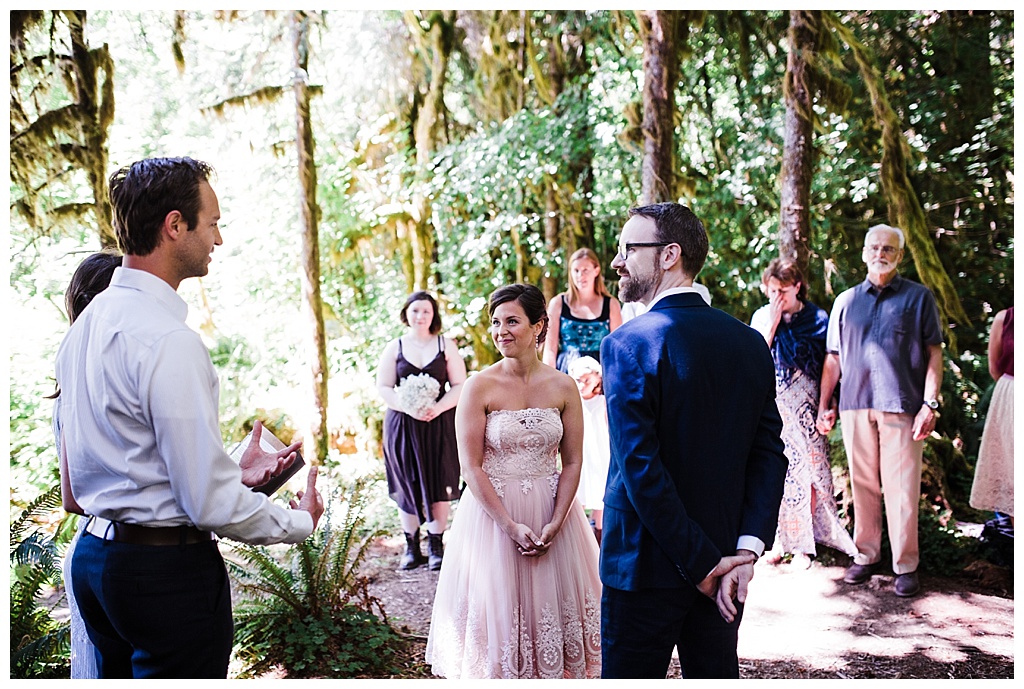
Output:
(817, 225), (942, 597)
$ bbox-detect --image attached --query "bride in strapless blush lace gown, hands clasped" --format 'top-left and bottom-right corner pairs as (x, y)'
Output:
(426, 285), (601, 679)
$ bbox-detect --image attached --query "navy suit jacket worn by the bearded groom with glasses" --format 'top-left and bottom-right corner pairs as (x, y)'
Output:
(601, 293), (788, 591)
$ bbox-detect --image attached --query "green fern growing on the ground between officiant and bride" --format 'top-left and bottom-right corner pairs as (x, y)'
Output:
(227, 472), (403, 677)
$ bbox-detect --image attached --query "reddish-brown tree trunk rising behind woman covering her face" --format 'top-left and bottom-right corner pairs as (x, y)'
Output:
(778, 9), (821, 275)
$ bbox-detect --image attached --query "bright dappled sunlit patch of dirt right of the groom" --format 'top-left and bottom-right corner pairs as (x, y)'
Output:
(738, 563), (1014, 677)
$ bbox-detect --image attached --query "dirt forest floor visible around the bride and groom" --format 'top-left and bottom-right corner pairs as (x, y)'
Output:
(360, 537), (1015, 679)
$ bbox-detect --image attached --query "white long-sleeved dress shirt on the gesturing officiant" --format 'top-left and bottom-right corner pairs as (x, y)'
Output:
(56, 267), (313, 544)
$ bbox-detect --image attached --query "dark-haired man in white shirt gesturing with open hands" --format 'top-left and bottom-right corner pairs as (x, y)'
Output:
(56, 158), (324, 679)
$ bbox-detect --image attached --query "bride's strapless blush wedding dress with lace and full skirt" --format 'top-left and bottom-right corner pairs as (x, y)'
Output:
(426, 408), (601, 679)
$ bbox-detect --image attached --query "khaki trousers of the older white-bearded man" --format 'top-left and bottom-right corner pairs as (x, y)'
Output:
(840, 410), (924, 574)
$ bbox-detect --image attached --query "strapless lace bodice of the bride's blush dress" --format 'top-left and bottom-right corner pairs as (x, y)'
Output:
(483, 408), (562, 483)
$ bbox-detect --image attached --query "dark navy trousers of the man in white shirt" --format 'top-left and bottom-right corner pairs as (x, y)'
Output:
(71, 533), (233, 679)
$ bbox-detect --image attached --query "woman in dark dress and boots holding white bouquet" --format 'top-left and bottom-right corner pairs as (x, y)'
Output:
(377, 291), (466, 570)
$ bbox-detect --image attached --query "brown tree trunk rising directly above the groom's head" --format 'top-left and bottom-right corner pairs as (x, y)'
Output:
(637, 9), (680, 205)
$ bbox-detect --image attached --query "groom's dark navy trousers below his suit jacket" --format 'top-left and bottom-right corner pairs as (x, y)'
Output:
(601, 586), (743, 680)
